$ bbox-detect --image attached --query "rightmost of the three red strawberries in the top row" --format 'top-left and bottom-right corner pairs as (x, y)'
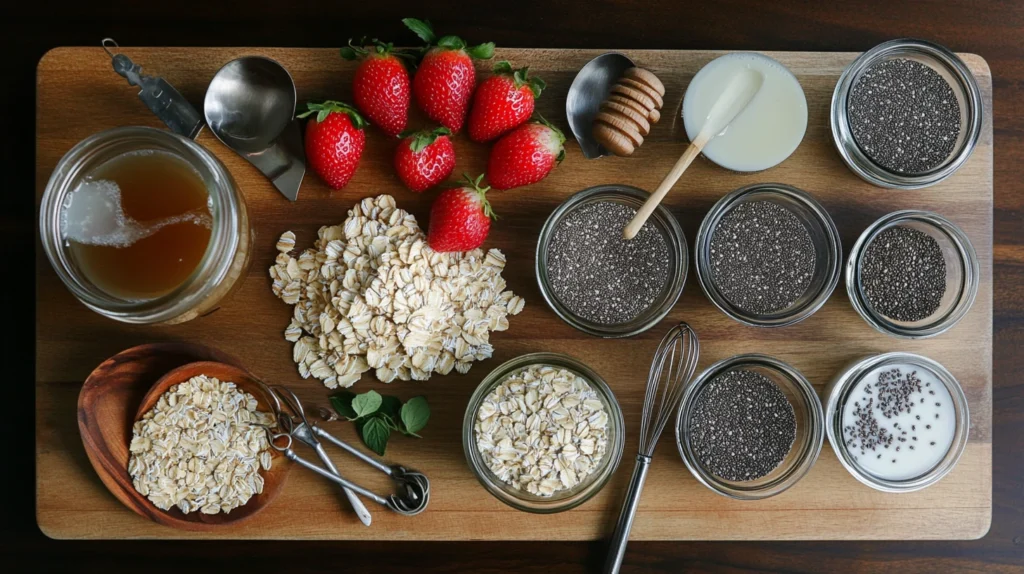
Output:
(469, 61), (546, 141)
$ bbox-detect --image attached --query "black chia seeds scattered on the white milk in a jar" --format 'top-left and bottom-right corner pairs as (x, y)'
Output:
(843, 368), (941, 463)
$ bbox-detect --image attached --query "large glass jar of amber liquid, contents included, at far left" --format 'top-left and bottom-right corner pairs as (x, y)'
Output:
(39, 127), (253, 323)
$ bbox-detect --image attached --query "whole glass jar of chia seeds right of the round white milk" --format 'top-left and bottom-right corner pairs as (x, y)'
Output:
(829, 39), (984, 189)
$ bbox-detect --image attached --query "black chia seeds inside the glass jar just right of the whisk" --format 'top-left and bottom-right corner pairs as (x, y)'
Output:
(689, 369), (797, 481)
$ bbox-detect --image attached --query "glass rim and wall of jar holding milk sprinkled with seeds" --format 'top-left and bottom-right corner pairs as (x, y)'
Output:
(824, 353), (971, 492)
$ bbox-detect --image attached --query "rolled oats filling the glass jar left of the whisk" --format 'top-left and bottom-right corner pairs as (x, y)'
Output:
(473, 365), (608, 496)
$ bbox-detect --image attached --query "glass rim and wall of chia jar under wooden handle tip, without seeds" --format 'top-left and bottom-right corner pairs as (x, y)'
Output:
(535, 184), (689, 338)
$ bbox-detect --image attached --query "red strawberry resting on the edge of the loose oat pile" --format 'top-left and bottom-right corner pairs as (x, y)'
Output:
(427, 175), (495, 252)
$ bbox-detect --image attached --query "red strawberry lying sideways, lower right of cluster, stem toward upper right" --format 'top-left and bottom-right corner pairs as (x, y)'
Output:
(487, 118), (565, 189)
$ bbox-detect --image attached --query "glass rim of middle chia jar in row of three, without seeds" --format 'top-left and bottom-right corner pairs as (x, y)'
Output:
(693, 183), (843, 327)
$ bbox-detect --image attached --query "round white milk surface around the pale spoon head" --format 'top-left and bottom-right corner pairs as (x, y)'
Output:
(683, 52), (807, 172)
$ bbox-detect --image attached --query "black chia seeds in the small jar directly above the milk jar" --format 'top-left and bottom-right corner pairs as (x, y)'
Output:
(860, 225), (946, 322)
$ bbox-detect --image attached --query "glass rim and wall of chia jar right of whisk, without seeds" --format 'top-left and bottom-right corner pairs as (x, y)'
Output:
(676, 354), (824, 500)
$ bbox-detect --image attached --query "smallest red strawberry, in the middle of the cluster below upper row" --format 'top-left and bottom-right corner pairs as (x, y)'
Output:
(394, 128), (455, 191)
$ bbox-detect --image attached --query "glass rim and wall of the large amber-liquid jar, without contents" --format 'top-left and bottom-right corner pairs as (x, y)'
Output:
(39, 127), (253, 324)
